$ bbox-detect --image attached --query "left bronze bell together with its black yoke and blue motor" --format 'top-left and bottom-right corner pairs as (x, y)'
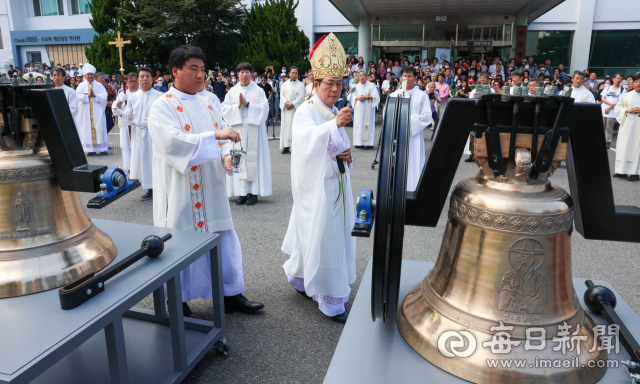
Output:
(0, 82), (139, 298)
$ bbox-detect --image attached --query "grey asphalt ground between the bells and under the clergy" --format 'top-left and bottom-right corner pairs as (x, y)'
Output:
(82, 121), (640, 384)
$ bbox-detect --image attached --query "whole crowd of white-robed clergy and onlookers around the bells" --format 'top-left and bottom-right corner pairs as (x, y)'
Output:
(41, 35), (640, 323)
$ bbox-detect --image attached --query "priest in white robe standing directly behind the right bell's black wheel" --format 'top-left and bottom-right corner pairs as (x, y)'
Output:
(391, 67), (433, 192)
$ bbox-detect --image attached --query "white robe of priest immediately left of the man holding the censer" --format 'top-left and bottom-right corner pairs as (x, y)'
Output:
(124, 88), (163, 189)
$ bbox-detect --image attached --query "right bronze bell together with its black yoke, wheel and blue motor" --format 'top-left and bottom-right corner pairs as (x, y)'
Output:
(352, 82), (640, 383)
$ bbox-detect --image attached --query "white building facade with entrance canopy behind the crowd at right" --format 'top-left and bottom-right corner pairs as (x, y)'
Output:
(254, 0), (640, 78)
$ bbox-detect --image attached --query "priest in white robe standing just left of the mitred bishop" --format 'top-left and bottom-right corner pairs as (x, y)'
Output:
(280, 67), (305, 153)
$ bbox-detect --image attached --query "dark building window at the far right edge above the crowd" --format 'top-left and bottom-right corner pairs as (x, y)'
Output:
(588, 30), (640, 78)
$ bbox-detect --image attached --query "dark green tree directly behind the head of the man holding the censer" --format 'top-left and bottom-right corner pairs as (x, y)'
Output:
(118, 0), (246, 70)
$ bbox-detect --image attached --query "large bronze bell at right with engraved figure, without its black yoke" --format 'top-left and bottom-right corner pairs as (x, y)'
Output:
(397, 142), (607, 384)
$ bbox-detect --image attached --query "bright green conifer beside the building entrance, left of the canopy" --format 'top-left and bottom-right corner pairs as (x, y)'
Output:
(236, 0), (310, 73)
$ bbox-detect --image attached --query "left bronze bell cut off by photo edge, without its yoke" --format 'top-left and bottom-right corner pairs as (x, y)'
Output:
(0, 85), (116, 298)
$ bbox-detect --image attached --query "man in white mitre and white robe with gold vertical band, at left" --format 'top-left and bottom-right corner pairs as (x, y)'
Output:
(76, 63), (109, 156)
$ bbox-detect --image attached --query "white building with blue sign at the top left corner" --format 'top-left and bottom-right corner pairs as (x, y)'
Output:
(0, 0), (95, 72)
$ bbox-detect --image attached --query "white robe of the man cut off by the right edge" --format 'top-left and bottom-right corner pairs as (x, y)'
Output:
(615, 90), (640, 175)
